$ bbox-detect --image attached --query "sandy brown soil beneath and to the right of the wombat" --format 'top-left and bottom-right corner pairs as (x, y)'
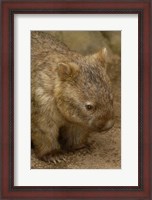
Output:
(31, 31), (121, 169)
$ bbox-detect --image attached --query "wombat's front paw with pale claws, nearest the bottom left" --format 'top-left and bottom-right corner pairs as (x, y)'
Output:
(42, 154), (66, 164)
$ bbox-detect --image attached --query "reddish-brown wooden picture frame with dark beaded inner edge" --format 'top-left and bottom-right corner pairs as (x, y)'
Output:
(0, 0), (152, 200)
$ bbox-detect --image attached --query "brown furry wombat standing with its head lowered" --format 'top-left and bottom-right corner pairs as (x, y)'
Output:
(31, 31), (114, 162)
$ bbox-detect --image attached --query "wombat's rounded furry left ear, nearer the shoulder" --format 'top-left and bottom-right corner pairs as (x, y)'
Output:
(58, 63), (79, 80)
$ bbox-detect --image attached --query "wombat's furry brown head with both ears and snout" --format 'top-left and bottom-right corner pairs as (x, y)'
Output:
(55, 49), (114, 131)
